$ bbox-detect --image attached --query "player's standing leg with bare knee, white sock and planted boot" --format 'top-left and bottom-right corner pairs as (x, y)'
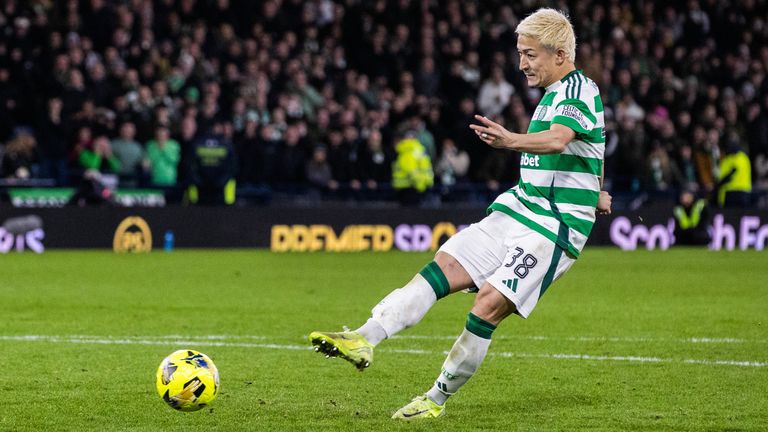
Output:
(392, 283), (515, 420)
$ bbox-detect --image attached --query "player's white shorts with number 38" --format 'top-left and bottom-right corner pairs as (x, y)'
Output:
(440, 212), (575, 318)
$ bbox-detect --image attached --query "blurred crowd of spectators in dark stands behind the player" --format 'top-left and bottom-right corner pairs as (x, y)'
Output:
(0, 0), (768, 206)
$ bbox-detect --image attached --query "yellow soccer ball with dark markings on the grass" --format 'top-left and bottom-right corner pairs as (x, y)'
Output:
(157, 350), (219, 411)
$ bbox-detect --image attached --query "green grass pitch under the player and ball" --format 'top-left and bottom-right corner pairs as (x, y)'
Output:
(0, 247), (768, 431)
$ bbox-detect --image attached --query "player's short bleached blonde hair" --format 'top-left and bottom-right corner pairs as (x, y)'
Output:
(515, 8), (576, 63)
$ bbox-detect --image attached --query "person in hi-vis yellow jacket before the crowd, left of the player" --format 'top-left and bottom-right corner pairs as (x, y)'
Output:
(392, 138), (434, 205)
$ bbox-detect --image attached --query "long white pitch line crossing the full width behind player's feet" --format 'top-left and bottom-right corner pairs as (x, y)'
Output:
(0, 335), (768, 368)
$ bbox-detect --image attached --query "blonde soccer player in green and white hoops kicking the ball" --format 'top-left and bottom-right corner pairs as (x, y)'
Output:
(310, 9), (611, 420)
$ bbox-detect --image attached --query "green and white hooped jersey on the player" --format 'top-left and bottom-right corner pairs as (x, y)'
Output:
(488, 70), (605, 257)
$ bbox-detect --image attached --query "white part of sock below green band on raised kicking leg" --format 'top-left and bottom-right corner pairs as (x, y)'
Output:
(357, 274), (437, 345)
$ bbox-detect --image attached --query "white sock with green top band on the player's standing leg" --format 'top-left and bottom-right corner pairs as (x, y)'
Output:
(427, 314), (496, 405)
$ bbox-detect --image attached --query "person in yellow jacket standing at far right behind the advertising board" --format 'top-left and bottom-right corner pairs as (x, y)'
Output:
(717, 143), (752, 207)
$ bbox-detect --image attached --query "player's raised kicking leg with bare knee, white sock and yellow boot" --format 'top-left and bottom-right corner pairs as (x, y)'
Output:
(309, 252), (474, 370)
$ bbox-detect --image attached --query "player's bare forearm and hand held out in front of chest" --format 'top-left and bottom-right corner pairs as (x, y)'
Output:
(469, 115), (576, 154)
